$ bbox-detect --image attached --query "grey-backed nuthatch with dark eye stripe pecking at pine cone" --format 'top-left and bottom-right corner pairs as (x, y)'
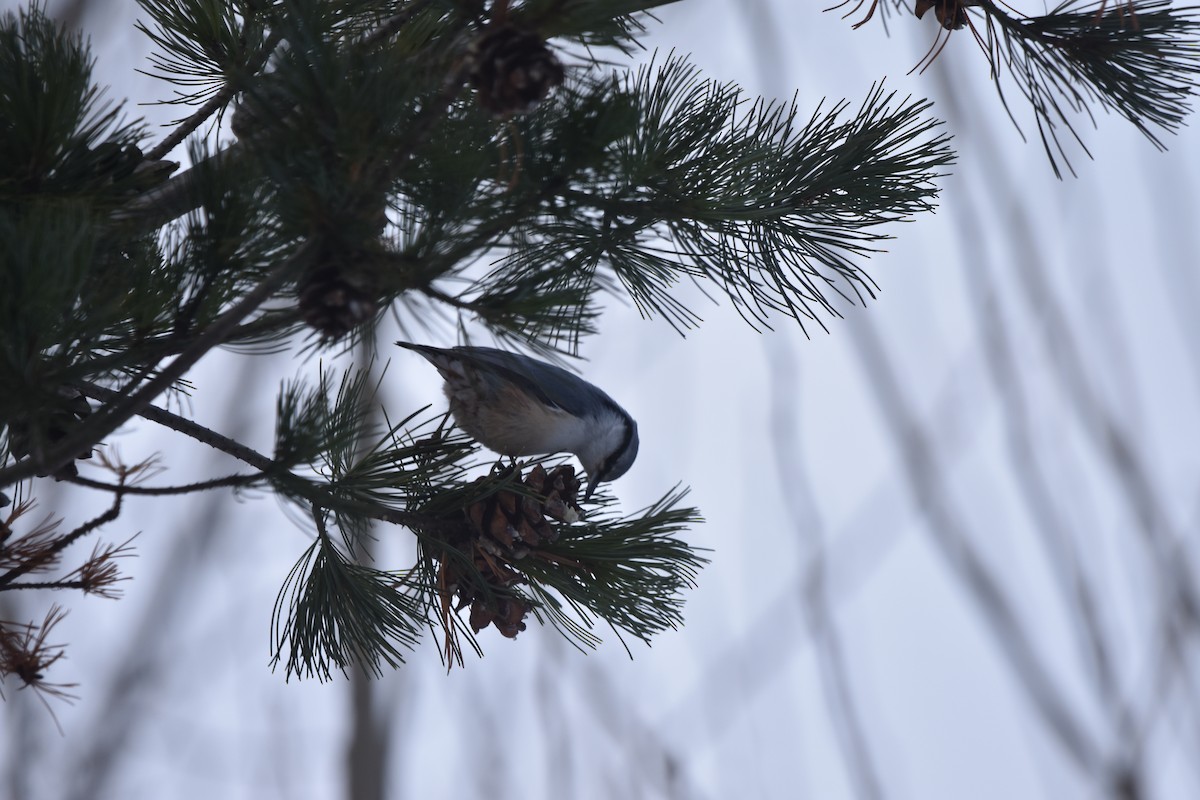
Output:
(396, 342), (637, 503)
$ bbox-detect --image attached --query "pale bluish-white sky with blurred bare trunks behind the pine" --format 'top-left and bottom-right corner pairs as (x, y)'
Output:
(0, 0), (1200, 800)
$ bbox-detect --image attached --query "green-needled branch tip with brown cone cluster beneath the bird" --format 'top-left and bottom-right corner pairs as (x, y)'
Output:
(272, 465), (706, 680)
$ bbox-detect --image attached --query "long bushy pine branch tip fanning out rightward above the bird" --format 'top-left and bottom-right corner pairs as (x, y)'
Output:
(489, 56), (953, 329)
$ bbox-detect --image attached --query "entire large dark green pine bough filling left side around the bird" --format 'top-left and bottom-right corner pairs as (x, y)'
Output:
(0, 0), (952, 678)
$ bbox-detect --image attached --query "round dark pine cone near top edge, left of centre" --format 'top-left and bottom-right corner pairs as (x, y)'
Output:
(468, 25), (565, 116)
